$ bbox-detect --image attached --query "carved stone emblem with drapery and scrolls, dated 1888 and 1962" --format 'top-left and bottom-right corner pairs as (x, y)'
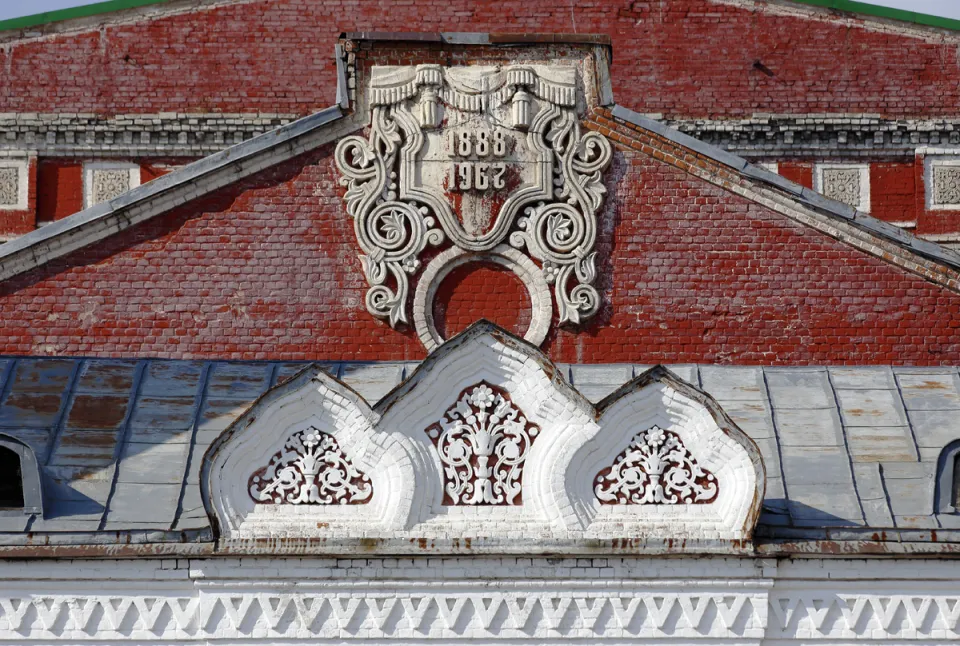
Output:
(336, 65), (612, 342)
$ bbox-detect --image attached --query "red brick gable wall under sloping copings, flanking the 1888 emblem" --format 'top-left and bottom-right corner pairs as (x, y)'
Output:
(0, 141), (960, 364)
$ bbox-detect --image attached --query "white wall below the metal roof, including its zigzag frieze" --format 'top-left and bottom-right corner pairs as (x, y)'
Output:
(0, 557), (960, 646)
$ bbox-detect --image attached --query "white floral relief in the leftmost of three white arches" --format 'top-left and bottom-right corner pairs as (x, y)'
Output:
(250, 427), (373, 505)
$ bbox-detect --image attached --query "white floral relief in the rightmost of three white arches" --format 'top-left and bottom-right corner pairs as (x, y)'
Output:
(594, 426), (719, 505)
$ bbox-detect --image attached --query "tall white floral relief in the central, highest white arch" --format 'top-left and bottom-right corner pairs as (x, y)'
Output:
(427, 382), (540, 505)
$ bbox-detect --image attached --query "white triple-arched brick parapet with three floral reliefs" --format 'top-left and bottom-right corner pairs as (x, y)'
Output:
(202, 321), (764, 554)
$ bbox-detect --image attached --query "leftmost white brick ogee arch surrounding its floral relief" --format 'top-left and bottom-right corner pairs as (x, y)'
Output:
(201, 368), (414, 541)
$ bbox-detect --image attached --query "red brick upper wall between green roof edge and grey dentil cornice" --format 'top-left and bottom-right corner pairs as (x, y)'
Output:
(0, 0), (960, 117)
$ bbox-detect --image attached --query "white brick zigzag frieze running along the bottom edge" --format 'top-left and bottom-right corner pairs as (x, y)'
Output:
(0, 580), (960, 643)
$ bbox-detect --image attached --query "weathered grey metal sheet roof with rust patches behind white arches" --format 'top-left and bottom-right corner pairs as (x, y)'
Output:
(0, 358), (960, 544)
